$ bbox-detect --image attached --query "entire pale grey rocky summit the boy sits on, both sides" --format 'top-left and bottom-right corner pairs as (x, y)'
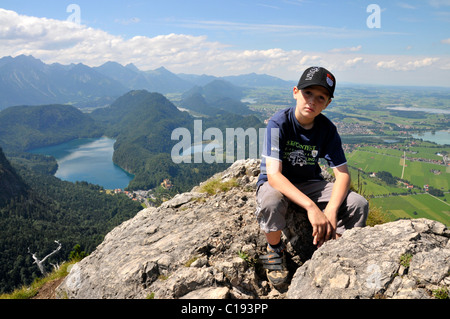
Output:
(57, 160), (450, 299)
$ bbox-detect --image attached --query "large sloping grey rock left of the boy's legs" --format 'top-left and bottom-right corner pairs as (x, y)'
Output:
(57, 160), (270, 298)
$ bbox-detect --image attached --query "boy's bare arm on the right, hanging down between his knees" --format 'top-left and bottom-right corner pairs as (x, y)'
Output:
(324, 164), (350, 238)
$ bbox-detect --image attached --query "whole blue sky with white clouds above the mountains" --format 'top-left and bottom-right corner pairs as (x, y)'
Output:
(0, 0), (450, 86)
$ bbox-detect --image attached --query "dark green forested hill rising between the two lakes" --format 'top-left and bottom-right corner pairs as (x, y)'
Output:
(91, 90), (263, 191)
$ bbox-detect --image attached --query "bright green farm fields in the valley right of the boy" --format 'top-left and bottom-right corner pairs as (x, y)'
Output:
(347, 143), (450, 225)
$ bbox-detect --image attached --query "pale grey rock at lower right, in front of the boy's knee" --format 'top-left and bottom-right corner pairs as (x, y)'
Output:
(288, 219), (450, 299)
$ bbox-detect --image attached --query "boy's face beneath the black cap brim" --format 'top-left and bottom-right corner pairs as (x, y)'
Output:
(294, 85), (331, 119)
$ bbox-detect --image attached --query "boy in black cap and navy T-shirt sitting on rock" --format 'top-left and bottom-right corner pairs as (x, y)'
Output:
(256, 67), (368, 286)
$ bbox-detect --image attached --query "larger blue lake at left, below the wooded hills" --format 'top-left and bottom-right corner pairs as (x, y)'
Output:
(30, 137), (134, 189)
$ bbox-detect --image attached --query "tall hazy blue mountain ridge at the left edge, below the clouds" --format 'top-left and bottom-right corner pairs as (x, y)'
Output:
(0, 55), (126, 109)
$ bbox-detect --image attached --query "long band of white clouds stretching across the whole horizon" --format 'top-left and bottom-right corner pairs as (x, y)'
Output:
(0, 9), (450, 85)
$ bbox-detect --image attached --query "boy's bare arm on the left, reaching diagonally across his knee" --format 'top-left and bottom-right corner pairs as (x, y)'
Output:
(266, 157), (332, 247)
